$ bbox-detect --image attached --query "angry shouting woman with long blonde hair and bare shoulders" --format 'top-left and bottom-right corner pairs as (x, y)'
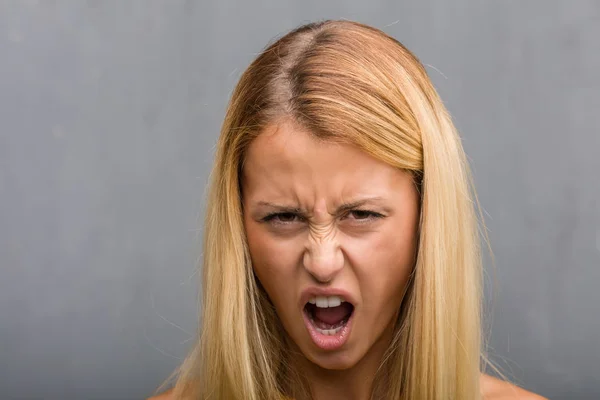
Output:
(149, 21), (539, 400)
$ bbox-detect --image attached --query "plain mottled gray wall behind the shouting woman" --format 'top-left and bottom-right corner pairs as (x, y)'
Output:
(0, 0), (600, 399)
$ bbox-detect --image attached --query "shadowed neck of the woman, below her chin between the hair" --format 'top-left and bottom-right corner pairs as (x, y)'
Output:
(296, 323), (394, 400)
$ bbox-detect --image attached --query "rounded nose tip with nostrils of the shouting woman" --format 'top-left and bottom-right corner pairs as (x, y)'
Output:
(303, 236), (344, 283)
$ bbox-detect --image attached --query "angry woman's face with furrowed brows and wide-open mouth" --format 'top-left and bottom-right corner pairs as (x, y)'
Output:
(242, 120), (419, 370)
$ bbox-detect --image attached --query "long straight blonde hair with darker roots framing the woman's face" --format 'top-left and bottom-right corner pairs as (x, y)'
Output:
(168, 20), (482, 400)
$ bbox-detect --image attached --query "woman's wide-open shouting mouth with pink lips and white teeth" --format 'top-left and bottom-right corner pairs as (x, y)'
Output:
(304, 296), (354, 350)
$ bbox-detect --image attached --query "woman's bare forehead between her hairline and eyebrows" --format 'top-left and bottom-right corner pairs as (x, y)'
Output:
(242, 120), (408, 203)
